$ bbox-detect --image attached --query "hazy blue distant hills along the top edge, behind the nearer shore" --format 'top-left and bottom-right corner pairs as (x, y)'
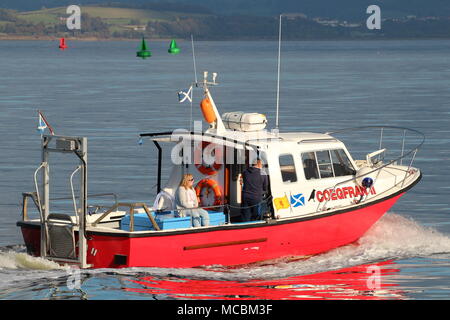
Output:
(0, 0), (450, 21)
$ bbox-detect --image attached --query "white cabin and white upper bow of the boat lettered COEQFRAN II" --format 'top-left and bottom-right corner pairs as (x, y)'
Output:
(145, 72), (420, 219)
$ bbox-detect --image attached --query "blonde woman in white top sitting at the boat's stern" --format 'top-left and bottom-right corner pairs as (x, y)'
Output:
(175, 173), (209, 227)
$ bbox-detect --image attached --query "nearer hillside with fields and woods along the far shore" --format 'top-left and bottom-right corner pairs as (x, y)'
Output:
(0, 5), (450, 40)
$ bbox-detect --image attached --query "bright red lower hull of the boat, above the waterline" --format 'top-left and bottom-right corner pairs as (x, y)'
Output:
(21, 194), (403, 268)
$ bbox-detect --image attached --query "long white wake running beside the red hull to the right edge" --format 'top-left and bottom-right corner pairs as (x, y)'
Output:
(119, 213), (450, 281)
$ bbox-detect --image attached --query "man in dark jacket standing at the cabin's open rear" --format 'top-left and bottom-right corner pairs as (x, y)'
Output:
(242, 159), (268, 221)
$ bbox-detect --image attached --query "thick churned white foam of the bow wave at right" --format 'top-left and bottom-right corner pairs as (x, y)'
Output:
(244, 213), (450, 277)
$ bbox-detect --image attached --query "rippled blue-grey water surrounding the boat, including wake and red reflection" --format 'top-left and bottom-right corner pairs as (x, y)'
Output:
(0, 40), (450, 300)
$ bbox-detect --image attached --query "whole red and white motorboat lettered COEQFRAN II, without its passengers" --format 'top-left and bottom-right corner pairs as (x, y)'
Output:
(17, 73), (424, 268)
